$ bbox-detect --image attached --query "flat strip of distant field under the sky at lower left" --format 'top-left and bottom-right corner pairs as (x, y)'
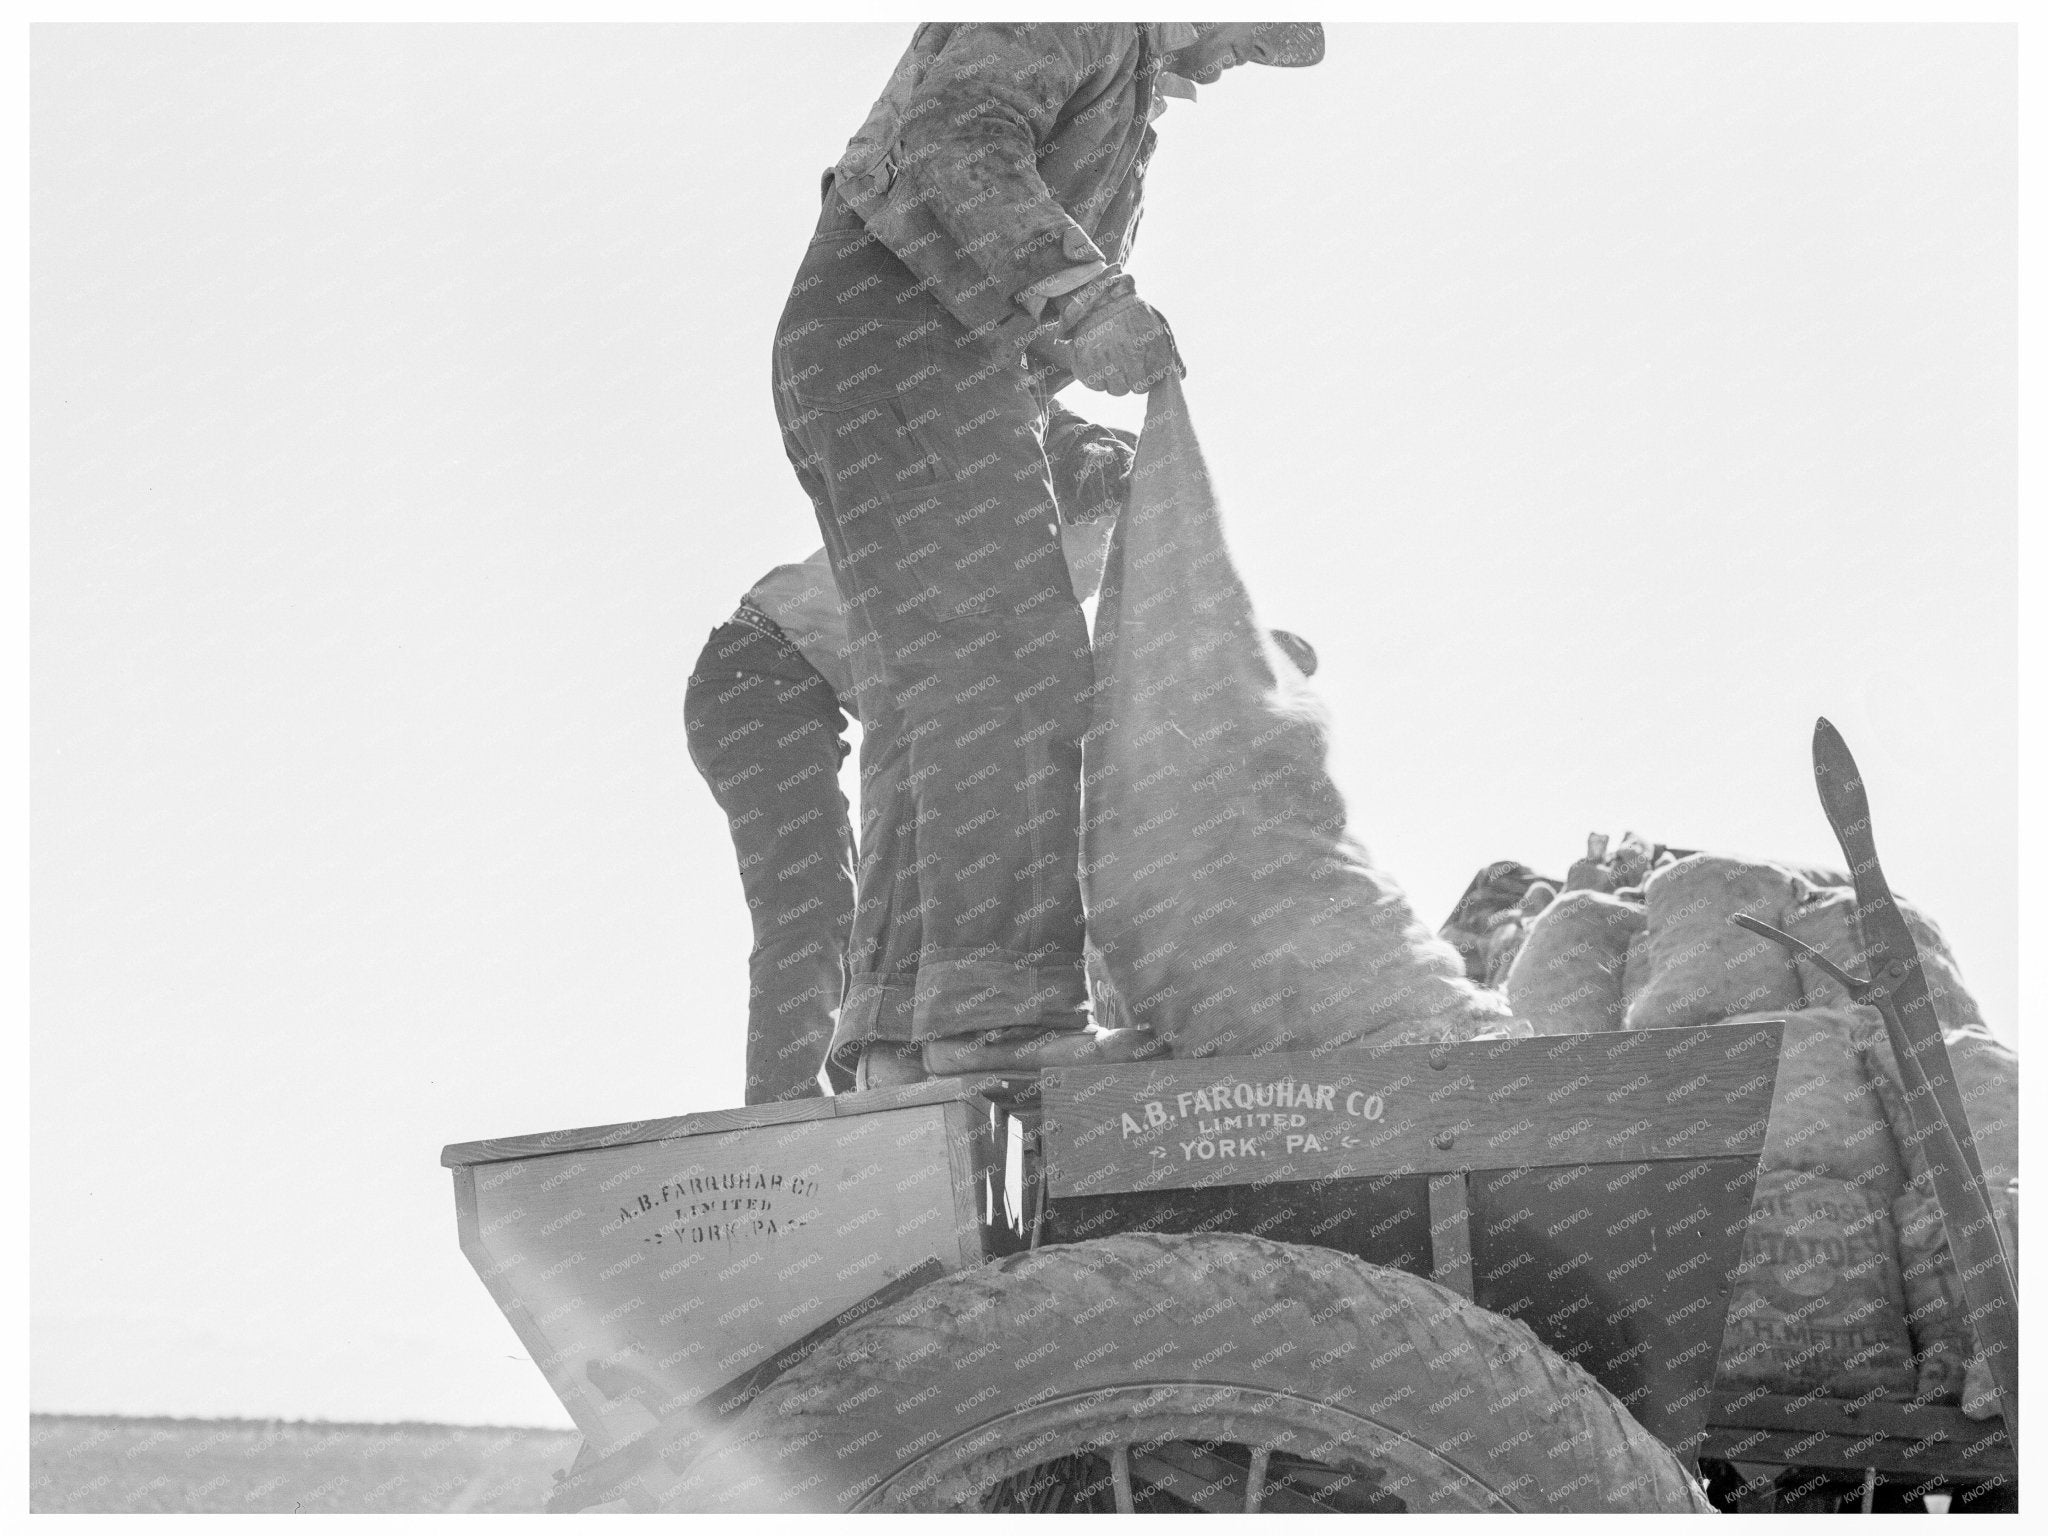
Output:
(29, 1413), (578, 1513)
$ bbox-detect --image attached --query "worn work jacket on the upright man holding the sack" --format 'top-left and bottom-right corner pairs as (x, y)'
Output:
(827, 20), (1161, 356)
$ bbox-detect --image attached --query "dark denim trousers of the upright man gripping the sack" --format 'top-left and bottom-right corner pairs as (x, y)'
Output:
(774, 215), (1094, 1073)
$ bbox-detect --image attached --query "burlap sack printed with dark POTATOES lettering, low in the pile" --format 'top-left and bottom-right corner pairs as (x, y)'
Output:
(1718, 1171), (1915, 1401)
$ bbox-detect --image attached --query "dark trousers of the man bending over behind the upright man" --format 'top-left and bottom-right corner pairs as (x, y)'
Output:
(684, 623), (854, 1104)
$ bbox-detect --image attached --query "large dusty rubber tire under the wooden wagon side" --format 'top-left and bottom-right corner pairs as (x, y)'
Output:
(676, 1233), (1712, 1513)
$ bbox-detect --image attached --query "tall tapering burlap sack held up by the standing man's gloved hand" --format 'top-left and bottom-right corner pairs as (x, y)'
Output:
(1081, 379), (1530, 1057)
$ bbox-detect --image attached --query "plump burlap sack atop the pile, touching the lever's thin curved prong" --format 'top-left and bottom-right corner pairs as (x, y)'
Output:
(1628, 854), (1800, 1030)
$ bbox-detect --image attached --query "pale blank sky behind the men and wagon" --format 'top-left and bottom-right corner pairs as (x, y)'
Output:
(33, 25), (2017, 1423)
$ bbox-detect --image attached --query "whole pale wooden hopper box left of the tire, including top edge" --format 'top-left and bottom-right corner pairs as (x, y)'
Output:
(440, 1081), (1018, 1507)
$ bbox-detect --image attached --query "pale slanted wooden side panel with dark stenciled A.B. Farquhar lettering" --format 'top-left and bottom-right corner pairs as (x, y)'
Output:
(455, 1104), (985, 1474)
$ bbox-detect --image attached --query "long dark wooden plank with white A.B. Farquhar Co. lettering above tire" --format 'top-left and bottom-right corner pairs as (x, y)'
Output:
(1040, 1022), (1782, 1196)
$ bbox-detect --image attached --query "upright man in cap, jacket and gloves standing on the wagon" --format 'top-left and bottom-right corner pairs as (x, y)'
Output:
(774, 23), (1323, 1085)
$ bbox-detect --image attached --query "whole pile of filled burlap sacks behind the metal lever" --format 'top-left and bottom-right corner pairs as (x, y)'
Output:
(1446, 834), (2019, 1417)
